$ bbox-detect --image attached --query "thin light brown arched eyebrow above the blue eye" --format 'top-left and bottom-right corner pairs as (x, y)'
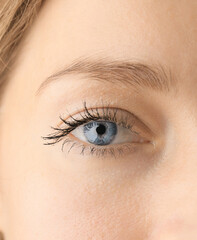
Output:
(36, 57), (176, 95)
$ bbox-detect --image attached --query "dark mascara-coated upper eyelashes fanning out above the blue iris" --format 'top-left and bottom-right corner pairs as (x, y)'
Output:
(42, 102), (138, 145)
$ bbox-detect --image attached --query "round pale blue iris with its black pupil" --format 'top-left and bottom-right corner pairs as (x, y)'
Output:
(83, 121), (117, 145)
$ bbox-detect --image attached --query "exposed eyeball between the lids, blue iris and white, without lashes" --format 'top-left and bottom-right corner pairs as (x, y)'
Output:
(71, 121), (145, 146)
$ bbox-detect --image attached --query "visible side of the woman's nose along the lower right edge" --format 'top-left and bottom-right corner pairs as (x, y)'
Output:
(150, 120), (197, 240)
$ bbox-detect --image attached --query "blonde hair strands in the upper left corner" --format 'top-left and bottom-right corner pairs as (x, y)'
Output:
(0, 0), (43, 88)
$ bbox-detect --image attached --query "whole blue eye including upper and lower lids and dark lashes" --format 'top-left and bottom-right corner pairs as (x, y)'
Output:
(43, 102), (153, 157)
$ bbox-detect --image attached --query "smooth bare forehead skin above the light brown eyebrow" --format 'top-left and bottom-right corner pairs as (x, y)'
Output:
(16, 0), (197, 94)
